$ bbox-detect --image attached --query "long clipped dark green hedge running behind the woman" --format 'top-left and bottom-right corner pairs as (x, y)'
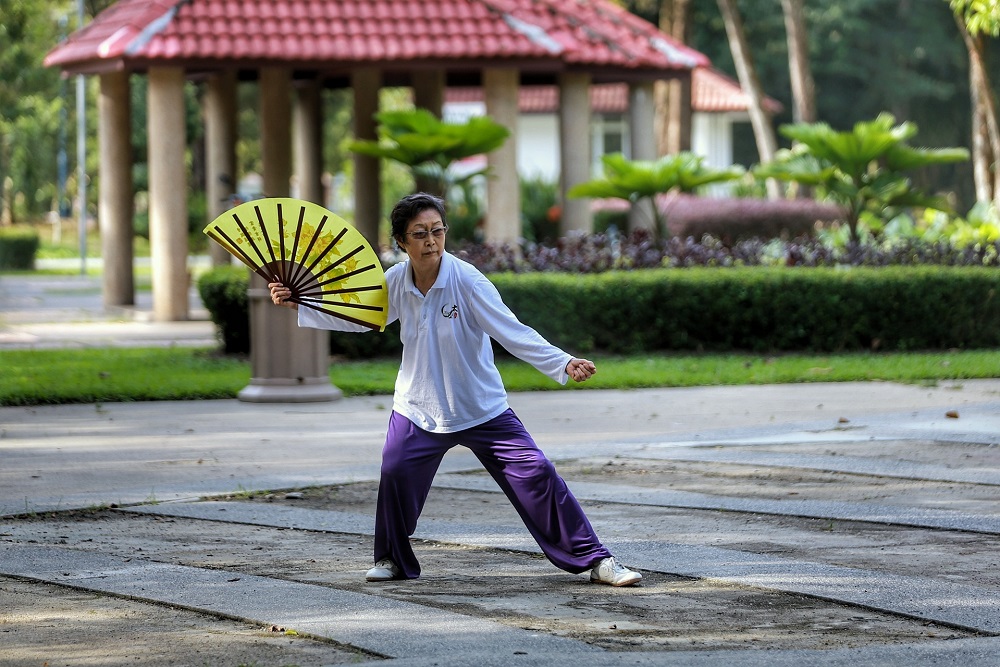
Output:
(199, 267), (1000, 358)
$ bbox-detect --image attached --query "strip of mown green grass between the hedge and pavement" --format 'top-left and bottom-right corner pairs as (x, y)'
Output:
(0, 348), (1000, 406)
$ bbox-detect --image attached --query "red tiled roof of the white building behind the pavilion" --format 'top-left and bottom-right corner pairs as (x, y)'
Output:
(445, 67), (782, 113)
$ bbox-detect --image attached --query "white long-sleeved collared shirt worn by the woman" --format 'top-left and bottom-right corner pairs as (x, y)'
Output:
(298, 253), (572, 433)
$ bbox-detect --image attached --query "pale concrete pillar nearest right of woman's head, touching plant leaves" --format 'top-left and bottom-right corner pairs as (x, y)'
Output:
(483, 69), (521, 246)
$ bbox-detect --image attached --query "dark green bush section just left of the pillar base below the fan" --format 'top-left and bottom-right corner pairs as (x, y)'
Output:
(198, 266), (250, 354)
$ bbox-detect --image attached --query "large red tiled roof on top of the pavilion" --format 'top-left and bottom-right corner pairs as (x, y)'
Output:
(45, 0), (708, 72)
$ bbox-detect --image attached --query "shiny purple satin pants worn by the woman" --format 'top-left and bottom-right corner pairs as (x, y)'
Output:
(375, 409), (611, 579)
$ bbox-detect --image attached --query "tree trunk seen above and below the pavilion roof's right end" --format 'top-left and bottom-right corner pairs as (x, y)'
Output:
(654, 0), (691, 155)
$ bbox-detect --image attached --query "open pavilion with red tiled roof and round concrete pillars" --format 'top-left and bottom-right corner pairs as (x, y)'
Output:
(45, 0), (708, 400)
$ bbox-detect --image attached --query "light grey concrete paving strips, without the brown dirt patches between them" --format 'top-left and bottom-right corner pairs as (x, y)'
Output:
(0, 270), (1000, 667)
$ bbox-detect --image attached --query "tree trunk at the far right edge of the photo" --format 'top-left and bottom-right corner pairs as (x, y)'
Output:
(955, 15), (1000, 206)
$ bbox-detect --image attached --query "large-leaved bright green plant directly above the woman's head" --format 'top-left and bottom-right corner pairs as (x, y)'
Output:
(348, 109), (510, 195)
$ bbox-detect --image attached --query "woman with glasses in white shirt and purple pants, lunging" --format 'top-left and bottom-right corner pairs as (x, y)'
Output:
(269, 193), (642, 586)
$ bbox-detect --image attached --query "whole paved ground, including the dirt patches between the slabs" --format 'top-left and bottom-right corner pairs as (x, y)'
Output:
(0, 268), (1000, 667)
